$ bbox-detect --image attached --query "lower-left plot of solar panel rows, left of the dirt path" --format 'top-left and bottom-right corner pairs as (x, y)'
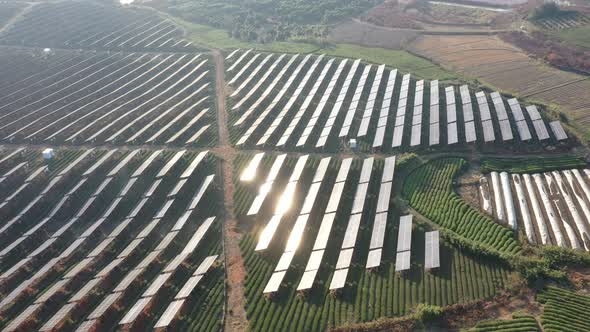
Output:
(0, 150), (223, 331)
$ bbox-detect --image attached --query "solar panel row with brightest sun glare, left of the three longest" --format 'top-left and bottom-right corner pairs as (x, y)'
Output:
(255, 155), (309, 251)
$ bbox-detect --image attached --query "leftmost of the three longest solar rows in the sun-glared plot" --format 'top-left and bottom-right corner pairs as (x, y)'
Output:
(263, 157), (331, 294)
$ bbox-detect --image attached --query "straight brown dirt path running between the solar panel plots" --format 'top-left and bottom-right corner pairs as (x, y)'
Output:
(213, 51), (248, 332)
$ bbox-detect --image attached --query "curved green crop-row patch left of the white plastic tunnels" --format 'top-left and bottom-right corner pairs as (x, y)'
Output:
(403, 158), (520, 253)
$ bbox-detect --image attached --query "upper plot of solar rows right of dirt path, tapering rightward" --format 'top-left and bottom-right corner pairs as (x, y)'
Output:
(226, 50), (569, 156)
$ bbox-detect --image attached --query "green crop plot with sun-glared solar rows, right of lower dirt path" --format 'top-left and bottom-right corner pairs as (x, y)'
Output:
(234, 153), (510, 331)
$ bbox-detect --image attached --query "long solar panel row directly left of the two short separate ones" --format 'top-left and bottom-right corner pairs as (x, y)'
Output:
(365, 156), (396, 269)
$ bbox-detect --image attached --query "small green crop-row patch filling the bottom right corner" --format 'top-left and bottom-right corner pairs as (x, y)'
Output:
(537, 286), (590, 332)
